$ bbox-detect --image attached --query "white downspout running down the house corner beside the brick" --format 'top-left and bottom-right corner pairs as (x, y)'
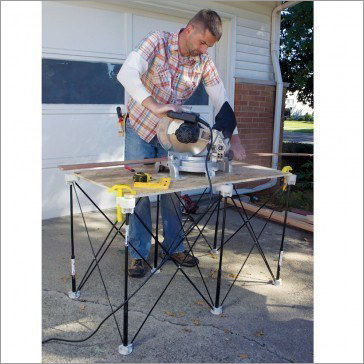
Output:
(238, 1), (302, 198)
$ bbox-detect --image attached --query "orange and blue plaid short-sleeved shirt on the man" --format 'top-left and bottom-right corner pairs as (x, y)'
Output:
(127, 31), (222, 142)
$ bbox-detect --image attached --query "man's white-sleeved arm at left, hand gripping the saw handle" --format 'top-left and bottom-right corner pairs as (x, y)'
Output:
(117, 32), (181, 117)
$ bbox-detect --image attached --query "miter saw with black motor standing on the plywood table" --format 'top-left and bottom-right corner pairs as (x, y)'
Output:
(157, 111), (232, 178)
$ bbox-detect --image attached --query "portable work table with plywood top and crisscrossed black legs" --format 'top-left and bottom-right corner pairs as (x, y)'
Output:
(43, 163), (295, 355)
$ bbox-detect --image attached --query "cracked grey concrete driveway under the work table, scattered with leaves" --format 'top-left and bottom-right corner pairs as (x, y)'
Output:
(43, 203), (313, 363)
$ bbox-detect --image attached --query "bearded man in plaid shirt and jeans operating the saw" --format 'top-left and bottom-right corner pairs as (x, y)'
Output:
(117, 10), (245, 277)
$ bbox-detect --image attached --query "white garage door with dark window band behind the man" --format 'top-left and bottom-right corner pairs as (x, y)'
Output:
(42, 2), (215, 218)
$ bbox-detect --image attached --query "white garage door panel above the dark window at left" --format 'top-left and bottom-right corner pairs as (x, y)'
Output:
(42, 1), (126, 58)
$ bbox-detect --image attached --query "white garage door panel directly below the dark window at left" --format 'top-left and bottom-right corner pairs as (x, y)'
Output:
(42, 114), (124, 167)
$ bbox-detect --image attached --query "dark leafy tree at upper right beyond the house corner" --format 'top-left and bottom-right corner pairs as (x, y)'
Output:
(280, 1), (313, 107)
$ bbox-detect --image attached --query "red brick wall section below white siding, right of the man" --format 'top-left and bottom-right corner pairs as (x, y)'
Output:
(234, 80), (286, 188)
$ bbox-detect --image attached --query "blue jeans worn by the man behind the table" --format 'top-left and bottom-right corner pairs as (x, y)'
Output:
(125, 120), (184, 259)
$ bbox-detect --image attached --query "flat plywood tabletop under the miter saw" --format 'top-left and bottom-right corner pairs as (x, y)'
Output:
(74, 162), (290, 197)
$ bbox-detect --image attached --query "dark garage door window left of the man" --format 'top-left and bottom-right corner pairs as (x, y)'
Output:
(42, 59), (124, 105)
